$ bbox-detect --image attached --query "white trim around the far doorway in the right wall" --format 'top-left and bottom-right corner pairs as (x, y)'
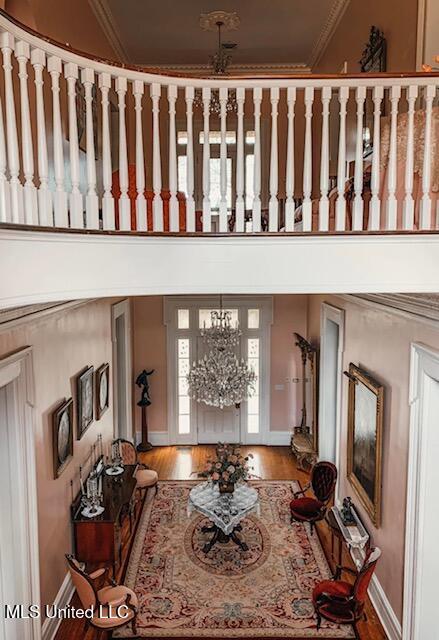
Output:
(319, 302), (345, 498)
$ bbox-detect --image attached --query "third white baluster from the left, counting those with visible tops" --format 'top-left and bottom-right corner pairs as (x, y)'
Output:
(31, 49), (53, 226)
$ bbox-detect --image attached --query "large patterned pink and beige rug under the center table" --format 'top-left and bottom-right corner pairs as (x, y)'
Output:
(113, 481), (355, 639)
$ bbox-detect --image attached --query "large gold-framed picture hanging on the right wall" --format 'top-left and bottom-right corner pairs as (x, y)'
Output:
(347, 363), (384, 527)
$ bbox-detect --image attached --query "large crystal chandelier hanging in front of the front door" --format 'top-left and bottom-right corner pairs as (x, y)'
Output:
(187, 309), (256, 409)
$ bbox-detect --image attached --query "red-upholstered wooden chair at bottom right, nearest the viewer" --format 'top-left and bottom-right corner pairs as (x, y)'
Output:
(312, 547), (381, 637)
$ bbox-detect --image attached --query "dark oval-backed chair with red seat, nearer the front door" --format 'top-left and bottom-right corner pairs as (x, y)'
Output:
(290, 461), (337, 533)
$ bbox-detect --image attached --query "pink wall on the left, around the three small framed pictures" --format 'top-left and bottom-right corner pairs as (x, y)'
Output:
(0, 300), (117, 616)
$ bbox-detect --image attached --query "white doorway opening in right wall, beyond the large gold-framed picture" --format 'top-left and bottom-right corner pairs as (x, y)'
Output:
(318, 303), (344, 480)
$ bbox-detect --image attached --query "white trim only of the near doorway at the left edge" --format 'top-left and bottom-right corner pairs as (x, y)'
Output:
(0, 347), (41, 640)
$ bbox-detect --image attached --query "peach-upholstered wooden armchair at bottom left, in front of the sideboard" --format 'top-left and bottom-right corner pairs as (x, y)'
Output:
(66, 555), (139, 636)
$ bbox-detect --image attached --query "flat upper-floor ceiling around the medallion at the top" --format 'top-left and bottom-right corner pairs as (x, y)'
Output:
(90, 0), (349, 68)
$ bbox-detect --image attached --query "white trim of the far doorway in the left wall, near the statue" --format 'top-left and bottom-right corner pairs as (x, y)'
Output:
(111, 299), (135, 440)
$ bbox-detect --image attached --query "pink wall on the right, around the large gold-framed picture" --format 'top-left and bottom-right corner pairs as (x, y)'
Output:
(308, 296), (439, 621)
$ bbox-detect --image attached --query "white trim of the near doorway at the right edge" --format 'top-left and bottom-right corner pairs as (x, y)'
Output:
(402, 343), (439, 640)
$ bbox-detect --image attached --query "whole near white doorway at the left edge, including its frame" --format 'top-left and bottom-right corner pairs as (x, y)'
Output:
(0, 348), (41, 640)
